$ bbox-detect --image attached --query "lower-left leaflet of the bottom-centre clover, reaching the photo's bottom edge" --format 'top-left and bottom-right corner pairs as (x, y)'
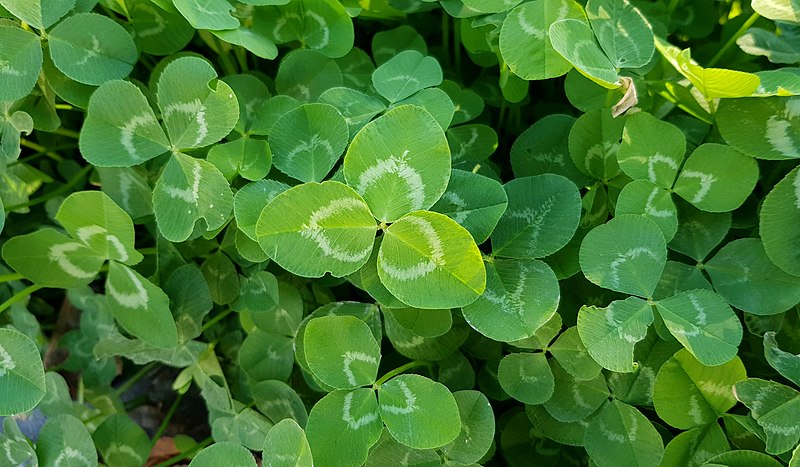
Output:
(306, 389), (383, 467)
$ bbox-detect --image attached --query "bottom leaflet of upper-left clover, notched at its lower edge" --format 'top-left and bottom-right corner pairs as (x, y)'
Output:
(153, 153), (233, 242)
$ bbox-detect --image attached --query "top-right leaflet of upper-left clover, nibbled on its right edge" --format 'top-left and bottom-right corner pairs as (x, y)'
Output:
(156, 57), (239, 149)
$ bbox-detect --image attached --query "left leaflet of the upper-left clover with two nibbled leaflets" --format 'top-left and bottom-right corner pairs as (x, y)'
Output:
(79, 81), (169, 167)
